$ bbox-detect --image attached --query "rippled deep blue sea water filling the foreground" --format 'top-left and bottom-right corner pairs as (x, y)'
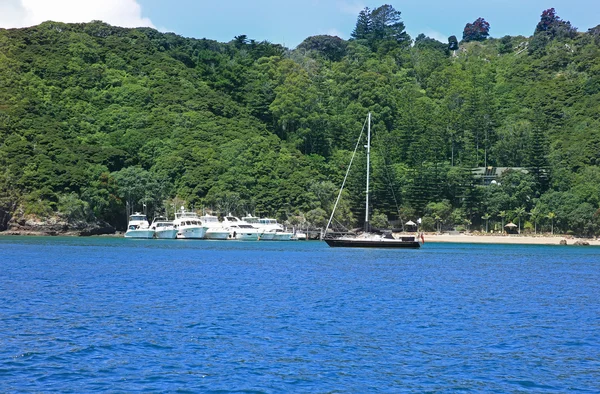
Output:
(0, 237), (600, 393)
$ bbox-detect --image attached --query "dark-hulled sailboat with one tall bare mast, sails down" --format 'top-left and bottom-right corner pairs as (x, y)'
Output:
(324, 112), (422, 249)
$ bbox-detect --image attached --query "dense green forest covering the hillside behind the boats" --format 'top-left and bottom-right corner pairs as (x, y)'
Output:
(0, 5), (600, 235)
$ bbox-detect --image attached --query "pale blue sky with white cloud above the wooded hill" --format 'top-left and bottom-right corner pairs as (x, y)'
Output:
(0, 0), (600, 49)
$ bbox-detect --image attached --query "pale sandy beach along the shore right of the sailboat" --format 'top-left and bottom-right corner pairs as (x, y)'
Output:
(424, 233), (600, 246)
